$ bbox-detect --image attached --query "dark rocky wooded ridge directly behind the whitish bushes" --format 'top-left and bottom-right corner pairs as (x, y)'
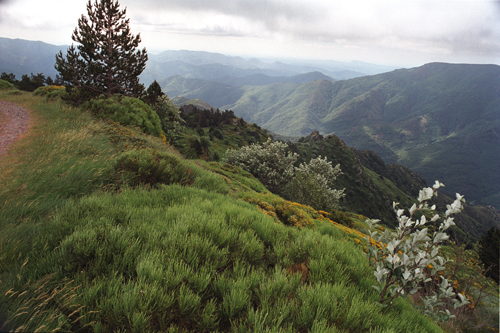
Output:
(290, 131), (500, 242)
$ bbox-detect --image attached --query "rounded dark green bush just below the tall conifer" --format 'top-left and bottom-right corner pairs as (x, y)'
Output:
(83, 95), (162, 136)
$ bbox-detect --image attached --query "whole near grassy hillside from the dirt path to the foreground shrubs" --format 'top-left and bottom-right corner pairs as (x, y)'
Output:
(0, 92), (446, 332)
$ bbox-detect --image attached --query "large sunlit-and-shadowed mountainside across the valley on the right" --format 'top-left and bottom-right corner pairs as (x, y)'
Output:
(167, 63), (500, 208)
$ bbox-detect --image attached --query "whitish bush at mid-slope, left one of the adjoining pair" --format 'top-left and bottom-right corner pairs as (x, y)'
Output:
(224, 138), (298, 193)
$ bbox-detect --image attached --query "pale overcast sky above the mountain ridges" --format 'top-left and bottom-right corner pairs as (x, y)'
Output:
(0, 0), (500, 67)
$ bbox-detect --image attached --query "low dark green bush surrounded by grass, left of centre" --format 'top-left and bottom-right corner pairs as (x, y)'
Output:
(111, 149), (194, 187)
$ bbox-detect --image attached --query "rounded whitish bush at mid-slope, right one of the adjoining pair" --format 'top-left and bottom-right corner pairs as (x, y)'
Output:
(283, 156), (344, 211)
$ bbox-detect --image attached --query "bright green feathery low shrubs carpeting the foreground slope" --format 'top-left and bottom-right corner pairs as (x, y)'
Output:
(0, 185), (440, 332)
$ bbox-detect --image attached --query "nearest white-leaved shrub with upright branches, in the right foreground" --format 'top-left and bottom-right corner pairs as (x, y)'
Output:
(366, 181), (469, 321)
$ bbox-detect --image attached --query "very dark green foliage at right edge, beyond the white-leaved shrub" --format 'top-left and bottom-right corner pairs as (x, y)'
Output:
(478, 228), (500, 284)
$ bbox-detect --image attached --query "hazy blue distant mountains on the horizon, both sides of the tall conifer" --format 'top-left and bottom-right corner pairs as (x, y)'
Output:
(0, 37), (394, 86)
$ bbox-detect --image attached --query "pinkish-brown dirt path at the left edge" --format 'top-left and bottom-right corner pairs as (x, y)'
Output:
(0, 101), (30, 158)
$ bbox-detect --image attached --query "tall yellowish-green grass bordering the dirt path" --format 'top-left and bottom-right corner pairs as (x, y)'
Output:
(0, 93), (116, 226)
